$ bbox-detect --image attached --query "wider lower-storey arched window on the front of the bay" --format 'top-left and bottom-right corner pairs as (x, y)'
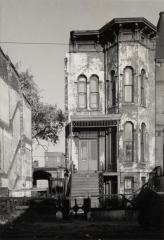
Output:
(124, 122), (134, 162)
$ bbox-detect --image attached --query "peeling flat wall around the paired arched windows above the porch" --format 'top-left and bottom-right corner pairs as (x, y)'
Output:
(66, 52), (105, 121)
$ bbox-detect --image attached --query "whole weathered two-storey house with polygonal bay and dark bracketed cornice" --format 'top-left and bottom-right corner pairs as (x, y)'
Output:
(65, 17), (160, 204)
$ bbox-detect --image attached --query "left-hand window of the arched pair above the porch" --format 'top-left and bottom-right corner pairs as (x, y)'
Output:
(78, 75), (87, 109)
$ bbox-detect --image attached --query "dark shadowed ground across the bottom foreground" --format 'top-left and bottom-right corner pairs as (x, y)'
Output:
(0, 206), (164, 240)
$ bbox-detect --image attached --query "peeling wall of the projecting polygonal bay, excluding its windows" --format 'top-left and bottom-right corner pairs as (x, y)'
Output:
(118, 42), (155, 192)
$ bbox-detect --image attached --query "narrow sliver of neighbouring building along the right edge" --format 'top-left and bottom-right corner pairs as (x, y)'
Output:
(155, 12), (164, 191)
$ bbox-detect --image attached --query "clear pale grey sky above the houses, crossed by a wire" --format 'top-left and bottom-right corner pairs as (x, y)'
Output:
(0, 0), (164, 152)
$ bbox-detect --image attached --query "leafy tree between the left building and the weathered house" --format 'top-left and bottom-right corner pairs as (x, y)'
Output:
(20, 70), (65, 143)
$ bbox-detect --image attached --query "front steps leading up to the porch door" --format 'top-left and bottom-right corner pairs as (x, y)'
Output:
(71, 172), (99, 207)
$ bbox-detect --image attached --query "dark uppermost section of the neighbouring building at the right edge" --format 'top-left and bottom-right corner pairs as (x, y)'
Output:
(156, 11), (164, 59)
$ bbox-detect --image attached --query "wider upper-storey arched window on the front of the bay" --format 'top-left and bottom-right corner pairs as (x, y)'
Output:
(124, 67), (134, 102)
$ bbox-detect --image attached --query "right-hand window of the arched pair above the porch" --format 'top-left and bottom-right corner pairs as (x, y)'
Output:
(90, 75), (99, 109)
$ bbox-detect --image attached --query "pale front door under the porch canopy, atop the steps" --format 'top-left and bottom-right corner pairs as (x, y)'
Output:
(78, 139), (98, 171)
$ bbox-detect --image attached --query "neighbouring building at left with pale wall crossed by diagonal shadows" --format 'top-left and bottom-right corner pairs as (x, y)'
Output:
(0, 49), (32, 197)
